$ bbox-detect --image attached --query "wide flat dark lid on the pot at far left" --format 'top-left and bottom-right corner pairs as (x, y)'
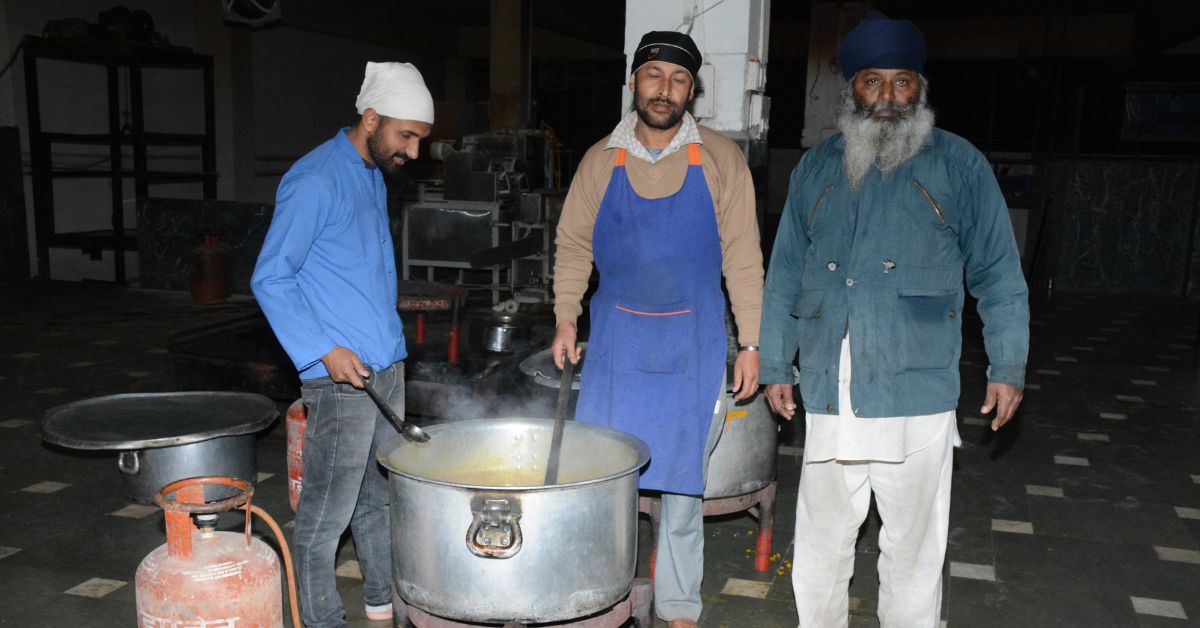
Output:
(42, 391), (280, 449)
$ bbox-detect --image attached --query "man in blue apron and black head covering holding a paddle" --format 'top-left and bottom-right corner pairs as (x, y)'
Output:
(551, 31), (762, 628)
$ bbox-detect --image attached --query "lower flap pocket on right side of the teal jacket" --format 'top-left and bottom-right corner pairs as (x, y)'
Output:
(893, 288), (962, 371)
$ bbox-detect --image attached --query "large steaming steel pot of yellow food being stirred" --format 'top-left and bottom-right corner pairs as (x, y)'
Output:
(379, 418), (649, 623)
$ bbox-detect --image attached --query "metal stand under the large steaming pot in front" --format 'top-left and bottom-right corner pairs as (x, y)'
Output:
(391, 578), (654, 628)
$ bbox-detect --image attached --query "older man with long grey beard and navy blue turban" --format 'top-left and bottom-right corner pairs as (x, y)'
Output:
(760, 12), (1030, 628)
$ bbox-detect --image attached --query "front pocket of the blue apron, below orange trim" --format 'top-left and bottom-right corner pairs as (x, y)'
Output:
(611, 301), (698, 373)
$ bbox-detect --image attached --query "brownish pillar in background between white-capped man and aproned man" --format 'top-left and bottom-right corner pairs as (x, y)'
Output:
(490, 0), (533, 131)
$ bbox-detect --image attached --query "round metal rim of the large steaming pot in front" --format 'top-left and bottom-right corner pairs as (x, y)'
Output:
(376, 417), (650, 492)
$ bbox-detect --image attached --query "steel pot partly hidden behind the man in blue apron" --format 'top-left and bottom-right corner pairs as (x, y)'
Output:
(704, 393), (779, 500)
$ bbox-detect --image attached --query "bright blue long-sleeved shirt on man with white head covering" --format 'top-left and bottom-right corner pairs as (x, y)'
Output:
(250, 128), (407, 379)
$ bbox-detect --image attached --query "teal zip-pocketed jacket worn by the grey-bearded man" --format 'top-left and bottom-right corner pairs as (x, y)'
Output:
(760, 128), (1030, 418)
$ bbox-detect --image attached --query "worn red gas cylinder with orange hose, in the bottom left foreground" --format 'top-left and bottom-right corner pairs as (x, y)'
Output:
(136, 477), (300, 628)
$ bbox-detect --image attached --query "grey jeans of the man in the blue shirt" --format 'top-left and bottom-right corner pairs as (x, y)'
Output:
(293, 363), (404, 628)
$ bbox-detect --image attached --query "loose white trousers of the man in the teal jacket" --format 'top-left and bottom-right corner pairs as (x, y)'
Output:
(792, 423), (958, 628)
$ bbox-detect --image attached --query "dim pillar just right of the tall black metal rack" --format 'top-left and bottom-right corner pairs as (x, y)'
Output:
(193, 0), (254, 201)
